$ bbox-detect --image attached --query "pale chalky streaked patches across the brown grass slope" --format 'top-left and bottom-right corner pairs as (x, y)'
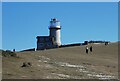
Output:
(37, 56), (117, 79)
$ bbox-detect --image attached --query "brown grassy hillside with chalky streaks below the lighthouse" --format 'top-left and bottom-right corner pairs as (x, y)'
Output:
(2, 43), (118, 79)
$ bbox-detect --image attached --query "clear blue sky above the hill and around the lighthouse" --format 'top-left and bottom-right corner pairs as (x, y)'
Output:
(2, 2), (118, 51)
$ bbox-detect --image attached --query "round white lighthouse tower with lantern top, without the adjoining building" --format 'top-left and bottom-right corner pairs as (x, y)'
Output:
(49, 18), (61, 46)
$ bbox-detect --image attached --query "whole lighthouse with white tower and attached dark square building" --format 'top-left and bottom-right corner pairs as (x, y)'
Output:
(36, 18), (61, 50)
